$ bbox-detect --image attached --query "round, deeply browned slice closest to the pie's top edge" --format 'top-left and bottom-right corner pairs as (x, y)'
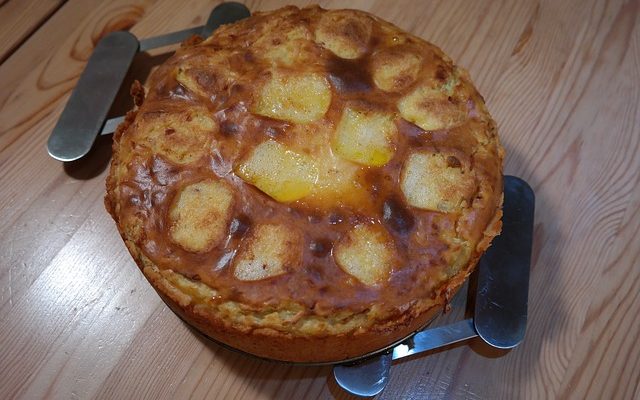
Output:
(316, 10), (371, 59)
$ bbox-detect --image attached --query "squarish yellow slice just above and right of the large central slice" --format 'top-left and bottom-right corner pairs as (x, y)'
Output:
(333, 108), (397, 167)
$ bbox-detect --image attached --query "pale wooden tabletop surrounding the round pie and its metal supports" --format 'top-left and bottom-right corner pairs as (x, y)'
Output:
(0, 0), (640, 399)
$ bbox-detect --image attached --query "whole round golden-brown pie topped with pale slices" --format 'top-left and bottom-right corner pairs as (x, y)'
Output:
(105, 7), (504, 362)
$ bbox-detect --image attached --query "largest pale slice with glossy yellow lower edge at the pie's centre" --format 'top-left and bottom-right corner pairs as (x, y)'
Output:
(235, 140), (318, 202)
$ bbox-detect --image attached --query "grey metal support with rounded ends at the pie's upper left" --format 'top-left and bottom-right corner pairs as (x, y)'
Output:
(47, 2), (251, 161)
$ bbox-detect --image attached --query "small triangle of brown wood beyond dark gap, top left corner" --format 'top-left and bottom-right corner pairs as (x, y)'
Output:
(0, 0), (65, 63)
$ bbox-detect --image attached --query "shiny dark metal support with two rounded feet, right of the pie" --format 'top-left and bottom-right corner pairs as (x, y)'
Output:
(333, 176), (535, 396)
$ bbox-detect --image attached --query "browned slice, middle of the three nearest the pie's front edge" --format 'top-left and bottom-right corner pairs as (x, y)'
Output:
(233, 225), (302, 281)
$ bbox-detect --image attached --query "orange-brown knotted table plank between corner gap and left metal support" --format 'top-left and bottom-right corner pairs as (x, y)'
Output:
(0, 0), (152, 154)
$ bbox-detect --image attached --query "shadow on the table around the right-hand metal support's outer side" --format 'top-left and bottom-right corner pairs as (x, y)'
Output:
(381, 142), (567, 398)
